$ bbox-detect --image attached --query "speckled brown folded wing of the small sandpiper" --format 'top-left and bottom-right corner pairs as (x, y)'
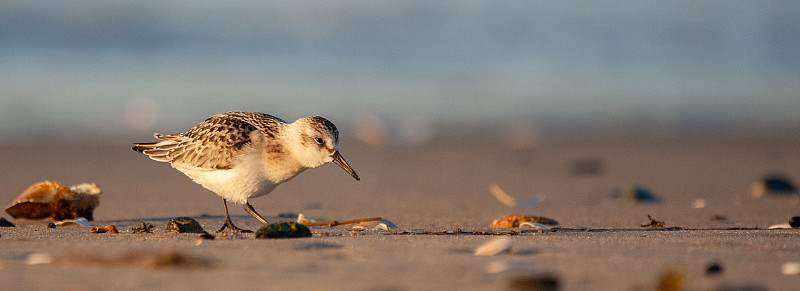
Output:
(133, 111), (283, 170)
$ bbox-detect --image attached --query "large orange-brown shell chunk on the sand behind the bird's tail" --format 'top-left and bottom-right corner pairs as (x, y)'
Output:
(6, 181), (100, 220)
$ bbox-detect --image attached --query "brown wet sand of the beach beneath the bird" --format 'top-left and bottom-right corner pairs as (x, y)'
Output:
(0, 135), (800, 290)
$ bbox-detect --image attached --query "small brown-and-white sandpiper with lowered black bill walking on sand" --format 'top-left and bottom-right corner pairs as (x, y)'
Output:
(133, 111), (360, 232)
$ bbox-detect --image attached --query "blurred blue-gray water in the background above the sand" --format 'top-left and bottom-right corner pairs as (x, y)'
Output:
(0, 0), (800, 142)
